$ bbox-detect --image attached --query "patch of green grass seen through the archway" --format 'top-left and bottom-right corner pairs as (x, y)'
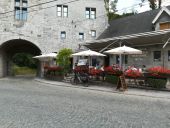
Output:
(13, 65), (36, 75)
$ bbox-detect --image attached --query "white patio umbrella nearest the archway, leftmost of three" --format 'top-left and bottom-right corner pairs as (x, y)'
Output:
(33, 53), (57, 61)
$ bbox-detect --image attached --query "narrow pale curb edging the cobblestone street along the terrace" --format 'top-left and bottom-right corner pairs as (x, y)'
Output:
(34, 79), (170, 100)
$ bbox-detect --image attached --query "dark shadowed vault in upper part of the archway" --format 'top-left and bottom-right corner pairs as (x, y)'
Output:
(1, 39), (41, 55)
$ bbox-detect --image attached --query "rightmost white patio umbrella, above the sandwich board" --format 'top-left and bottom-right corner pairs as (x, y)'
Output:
(105, 45), (142, 69)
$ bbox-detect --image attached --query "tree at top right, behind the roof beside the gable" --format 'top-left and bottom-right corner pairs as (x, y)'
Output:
(142, 0), (162, 10)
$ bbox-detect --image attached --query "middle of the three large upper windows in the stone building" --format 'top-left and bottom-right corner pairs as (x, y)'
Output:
(57, 5), (68, 17)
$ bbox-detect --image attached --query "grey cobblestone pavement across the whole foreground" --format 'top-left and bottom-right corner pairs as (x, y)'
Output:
(0, 78), (170, 128)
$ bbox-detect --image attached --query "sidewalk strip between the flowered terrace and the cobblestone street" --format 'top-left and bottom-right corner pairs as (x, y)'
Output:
(35, 78), (170, 100)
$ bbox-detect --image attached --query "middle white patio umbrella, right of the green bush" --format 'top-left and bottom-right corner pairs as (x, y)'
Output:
(72, 50), (106, 66)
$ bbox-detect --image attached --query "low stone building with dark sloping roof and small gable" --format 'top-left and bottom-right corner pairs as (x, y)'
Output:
(84, 6), (170, 68)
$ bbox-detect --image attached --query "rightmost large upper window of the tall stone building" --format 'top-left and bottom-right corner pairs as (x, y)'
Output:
(86, 8), (96, 19)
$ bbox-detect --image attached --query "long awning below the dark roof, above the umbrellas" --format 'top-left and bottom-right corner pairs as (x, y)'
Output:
(83, 29), (170, 51)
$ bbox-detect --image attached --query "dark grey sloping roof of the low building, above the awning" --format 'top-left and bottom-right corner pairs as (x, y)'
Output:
(98, 6), (170, 40)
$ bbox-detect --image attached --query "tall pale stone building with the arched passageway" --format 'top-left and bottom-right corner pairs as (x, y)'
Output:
(0, 0), (108, 77)
